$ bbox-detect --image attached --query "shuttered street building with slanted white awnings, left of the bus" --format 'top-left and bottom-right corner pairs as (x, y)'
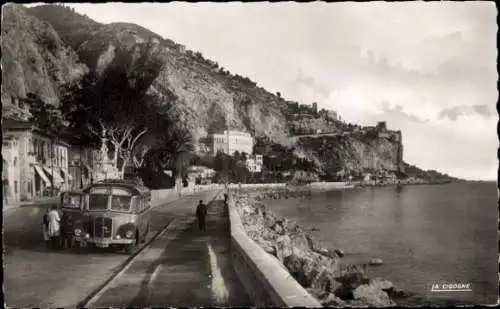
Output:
(3, 119), (71, 201)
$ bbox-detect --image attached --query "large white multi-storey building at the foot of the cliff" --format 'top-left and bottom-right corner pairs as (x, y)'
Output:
(212, 130), (254, 156)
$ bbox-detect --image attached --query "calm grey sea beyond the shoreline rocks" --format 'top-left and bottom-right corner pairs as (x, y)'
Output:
(265, 183), (498, 304)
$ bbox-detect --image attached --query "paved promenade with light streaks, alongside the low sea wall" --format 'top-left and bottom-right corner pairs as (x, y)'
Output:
(88, 201), (251, 308)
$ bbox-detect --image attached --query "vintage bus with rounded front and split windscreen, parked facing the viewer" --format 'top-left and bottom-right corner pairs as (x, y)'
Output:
(68, 180), (151, 253)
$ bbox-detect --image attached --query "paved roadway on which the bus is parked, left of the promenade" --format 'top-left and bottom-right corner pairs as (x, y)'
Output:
(3, 192), (235, 308)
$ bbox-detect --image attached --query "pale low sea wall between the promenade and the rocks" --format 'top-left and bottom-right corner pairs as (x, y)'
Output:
(228, 195), (323, 308)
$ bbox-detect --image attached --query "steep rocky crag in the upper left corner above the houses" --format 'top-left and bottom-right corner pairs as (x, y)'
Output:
(2, 4), (88, 106)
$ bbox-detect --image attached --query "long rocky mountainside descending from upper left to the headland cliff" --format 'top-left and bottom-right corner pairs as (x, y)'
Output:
(2, 4), (410, 178)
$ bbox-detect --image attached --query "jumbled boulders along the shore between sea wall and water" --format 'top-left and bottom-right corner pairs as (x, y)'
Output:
(229, 192), (414, 307)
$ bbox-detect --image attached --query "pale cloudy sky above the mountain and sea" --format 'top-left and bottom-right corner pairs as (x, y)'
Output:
(30, 1), (498, 180)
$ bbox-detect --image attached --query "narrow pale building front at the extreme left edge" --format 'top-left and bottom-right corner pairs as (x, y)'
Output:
(2, 136), (21, 205)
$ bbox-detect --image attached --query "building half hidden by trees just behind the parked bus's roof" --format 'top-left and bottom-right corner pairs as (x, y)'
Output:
(68, 146), (100, 189)
